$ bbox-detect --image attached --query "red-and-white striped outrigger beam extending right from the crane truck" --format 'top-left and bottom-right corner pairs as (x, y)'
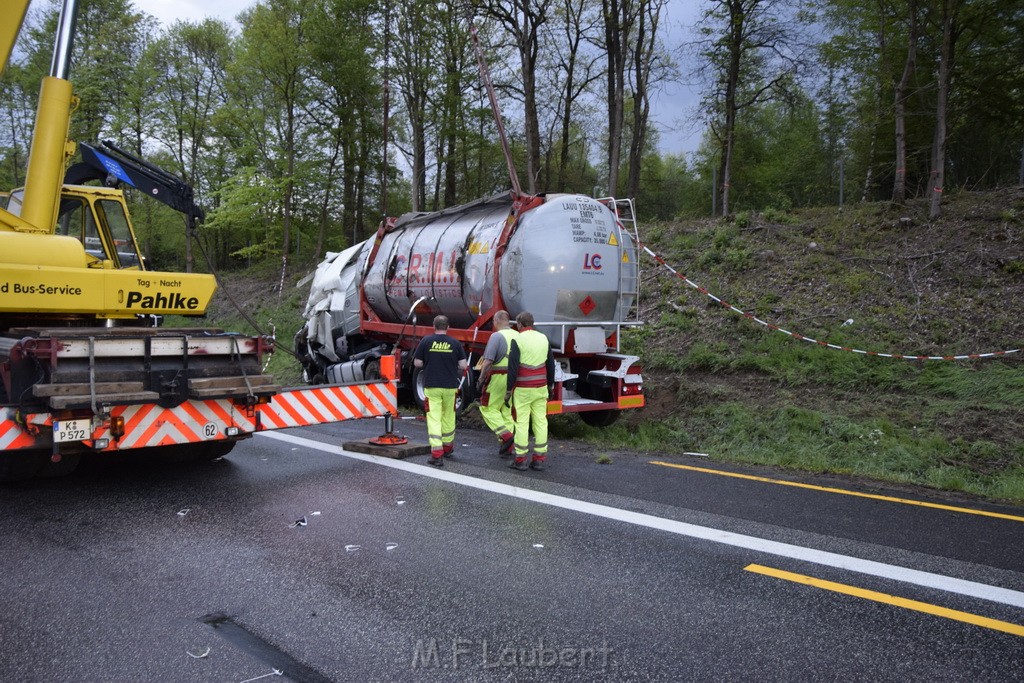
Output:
(258, 382), (398, 431)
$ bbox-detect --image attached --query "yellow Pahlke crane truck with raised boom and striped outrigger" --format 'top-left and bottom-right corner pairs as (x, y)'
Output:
(0, 0), (396, 480)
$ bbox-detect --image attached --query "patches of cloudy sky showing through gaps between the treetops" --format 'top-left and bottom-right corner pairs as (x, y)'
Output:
(135, 0), (703, 155)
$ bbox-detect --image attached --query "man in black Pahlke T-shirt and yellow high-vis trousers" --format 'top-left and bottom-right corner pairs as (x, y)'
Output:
(413, 315), (468, 467)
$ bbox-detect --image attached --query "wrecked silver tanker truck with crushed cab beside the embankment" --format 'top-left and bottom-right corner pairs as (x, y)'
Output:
(295, 193), (644, 426)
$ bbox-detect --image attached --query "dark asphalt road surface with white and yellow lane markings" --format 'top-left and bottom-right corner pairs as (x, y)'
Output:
(0, 413), (1024, 681)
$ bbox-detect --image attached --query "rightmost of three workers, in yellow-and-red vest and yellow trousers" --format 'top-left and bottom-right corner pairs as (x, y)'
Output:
(505, 310), (555, 470)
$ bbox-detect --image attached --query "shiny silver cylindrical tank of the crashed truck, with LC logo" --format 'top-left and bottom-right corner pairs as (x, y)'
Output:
(364, 195), (636, 328)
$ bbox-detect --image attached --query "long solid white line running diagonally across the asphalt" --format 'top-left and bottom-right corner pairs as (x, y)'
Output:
(259, 432), (1024, 608)
